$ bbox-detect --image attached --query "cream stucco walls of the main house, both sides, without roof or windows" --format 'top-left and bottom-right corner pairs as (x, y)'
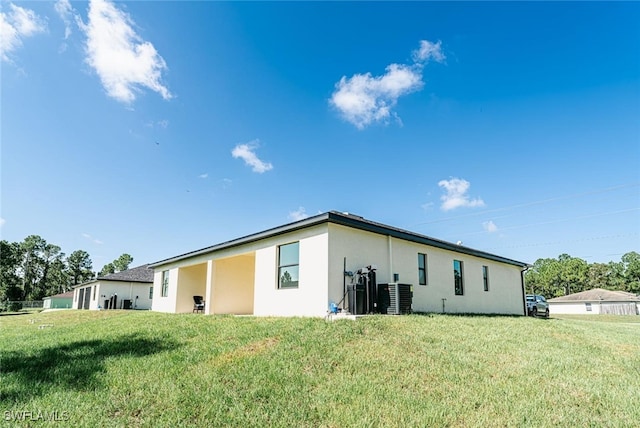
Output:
(153, 223), (524, 316)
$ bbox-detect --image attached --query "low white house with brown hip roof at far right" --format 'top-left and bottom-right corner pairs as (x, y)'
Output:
(549, 288), (640, 315)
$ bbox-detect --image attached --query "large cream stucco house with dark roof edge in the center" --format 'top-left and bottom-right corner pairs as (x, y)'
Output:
(149, 211), (527, 316)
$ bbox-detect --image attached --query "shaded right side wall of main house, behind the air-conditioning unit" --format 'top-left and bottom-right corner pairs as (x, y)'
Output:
(329, 224), (524, 315)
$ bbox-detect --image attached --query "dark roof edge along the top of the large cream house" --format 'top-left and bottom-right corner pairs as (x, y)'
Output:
(149, 211), (529, 268)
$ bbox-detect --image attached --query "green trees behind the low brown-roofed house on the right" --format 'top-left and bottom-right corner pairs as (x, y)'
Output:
(525, 251), (640, 299)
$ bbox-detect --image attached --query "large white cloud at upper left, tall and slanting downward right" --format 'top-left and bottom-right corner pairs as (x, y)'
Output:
(77, 0), (172, 104)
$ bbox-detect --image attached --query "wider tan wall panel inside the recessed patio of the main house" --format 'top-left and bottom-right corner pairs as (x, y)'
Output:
(212, 253), (256, 315)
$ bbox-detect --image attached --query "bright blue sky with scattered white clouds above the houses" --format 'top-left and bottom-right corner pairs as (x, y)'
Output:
(0, 0), (640, 270)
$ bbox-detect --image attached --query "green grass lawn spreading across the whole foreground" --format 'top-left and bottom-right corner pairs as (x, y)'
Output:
(0, 310), (640, 427)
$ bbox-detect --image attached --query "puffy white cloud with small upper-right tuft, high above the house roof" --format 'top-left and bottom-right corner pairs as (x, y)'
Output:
(329, 40), (445, 129)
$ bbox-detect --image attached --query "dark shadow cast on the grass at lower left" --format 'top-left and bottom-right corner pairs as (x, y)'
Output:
(0, 335), (178, 406)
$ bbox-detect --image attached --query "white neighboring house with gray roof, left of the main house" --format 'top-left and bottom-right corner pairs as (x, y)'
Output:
(73, 265), (153, 309)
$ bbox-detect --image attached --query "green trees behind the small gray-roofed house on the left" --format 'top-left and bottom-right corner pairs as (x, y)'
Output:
(0, 235), (133, 303)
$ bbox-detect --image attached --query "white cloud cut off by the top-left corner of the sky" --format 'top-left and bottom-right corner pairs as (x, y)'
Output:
(0, 3), (47, 62)
